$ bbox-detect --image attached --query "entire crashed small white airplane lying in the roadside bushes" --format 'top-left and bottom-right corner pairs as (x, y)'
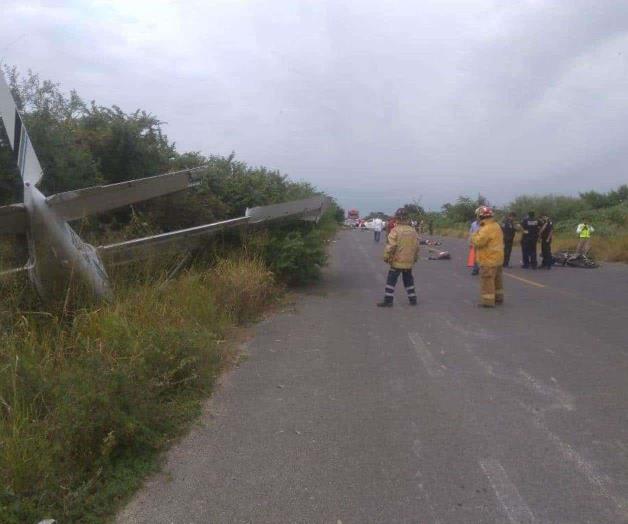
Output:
(0, 73), (330, 300)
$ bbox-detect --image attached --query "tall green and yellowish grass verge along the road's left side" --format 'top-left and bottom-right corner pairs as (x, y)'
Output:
(0, 257), (279, 524)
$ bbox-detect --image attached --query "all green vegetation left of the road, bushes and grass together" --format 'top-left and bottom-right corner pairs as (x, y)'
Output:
(0, 66), (337, 523)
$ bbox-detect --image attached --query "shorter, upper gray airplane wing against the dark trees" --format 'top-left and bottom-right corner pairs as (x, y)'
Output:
(46, 166), (205, 220)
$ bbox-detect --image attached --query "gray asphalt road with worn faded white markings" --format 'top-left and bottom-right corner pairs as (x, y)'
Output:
(118, 231), (628, 524)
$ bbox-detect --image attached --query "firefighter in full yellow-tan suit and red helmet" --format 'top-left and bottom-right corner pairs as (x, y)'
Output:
(472, 206), (504, 307)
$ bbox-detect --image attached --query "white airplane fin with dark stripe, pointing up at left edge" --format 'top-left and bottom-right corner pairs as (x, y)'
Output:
(0, 72), (43, 185)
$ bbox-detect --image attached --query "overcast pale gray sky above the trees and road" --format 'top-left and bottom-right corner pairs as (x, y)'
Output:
(0, 0), (628, 213)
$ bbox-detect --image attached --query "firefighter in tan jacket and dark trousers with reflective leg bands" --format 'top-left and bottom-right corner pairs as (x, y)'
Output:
(377, 208), (419, 307)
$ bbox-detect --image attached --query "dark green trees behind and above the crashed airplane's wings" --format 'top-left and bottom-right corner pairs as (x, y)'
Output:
(0, 67), (318, 234)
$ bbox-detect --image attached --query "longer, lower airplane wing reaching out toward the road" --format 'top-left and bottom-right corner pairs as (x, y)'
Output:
(96, 196), (329, 265)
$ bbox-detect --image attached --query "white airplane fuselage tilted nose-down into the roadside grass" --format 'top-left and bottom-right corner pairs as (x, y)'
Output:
(24, 182), (112, 299)
